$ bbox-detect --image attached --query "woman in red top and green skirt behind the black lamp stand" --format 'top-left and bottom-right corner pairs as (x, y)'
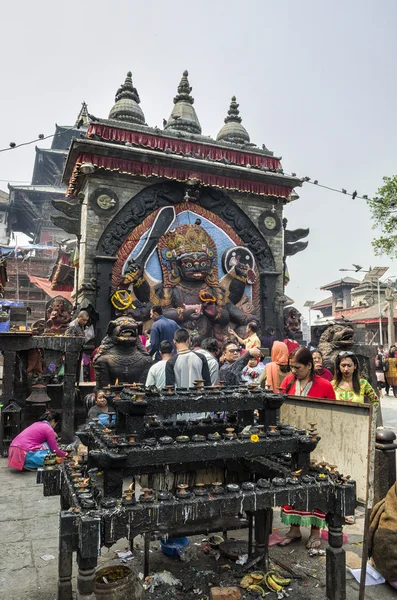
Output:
(279, 348), (335, 549)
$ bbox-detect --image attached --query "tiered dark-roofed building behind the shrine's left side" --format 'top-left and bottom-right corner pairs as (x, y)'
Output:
(0, 103), (88, 323)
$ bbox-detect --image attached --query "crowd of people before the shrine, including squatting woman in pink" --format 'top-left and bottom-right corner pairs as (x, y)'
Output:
(9, 306), (382, 564)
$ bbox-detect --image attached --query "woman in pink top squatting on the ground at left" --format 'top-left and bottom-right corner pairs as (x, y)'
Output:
(8, 410), (66, 471)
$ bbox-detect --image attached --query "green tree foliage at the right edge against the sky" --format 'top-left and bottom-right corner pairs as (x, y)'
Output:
(368, 175), (397, 258)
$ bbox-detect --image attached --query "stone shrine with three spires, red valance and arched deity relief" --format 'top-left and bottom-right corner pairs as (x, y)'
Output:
(53, 71), (308, 340)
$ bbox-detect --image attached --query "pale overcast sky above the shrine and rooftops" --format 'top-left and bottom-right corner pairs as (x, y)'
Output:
(0, 0), (397, 316)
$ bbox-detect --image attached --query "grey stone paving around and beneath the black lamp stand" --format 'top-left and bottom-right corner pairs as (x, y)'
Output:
(0, 459), (396, 600)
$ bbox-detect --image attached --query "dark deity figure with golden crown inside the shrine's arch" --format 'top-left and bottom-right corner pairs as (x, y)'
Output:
(125, 225), (253, 339)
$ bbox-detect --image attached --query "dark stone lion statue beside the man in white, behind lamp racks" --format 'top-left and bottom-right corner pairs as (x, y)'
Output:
(94, 317), (152, 389)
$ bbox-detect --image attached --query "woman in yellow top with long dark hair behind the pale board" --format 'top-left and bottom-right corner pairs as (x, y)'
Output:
(331, 350), (378, 404)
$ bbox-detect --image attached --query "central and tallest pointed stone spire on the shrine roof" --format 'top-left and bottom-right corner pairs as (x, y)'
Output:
(164, 70), (201, 135)
